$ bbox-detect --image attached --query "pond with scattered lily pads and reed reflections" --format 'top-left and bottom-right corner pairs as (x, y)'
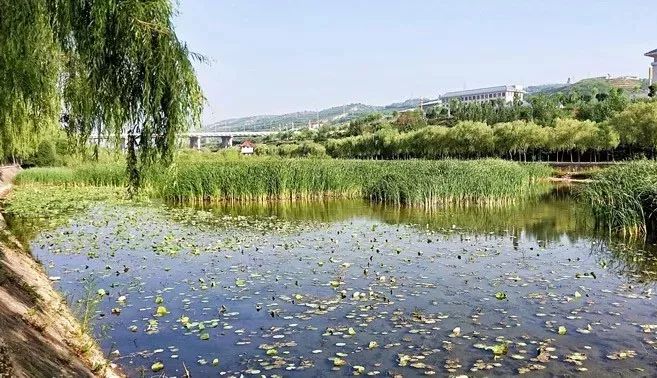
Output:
(21, 188), (657, 377)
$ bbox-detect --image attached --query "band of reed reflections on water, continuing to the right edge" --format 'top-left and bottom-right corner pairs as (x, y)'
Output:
(179, 189), (657, 282)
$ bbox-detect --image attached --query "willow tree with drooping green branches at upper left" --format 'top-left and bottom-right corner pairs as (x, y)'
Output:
(0, 0), (203, 188)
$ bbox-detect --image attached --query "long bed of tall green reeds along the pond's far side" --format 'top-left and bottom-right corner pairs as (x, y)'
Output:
(17, 157), (551, 206)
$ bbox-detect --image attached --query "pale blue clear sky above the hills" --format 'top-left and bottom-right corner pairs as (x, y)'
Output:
(174, 0), (657, 124)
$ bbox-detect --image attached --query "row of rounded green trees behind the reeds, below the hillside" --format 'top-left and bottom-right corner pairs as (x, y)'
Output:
(326, 101), (657, 161)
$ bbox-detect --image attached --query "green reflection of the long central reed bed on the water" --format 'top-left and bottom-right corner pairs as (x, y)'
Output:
(188, 188), (594, 244)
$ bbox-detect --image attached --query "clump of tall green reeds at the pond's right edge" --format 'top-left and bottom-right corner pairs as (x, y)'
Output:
(580, 161), (657, 236)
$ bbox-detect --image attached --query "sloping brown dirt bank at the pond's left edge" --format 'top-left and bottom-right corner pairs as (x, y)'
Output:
(0, 167), (122, 378)
